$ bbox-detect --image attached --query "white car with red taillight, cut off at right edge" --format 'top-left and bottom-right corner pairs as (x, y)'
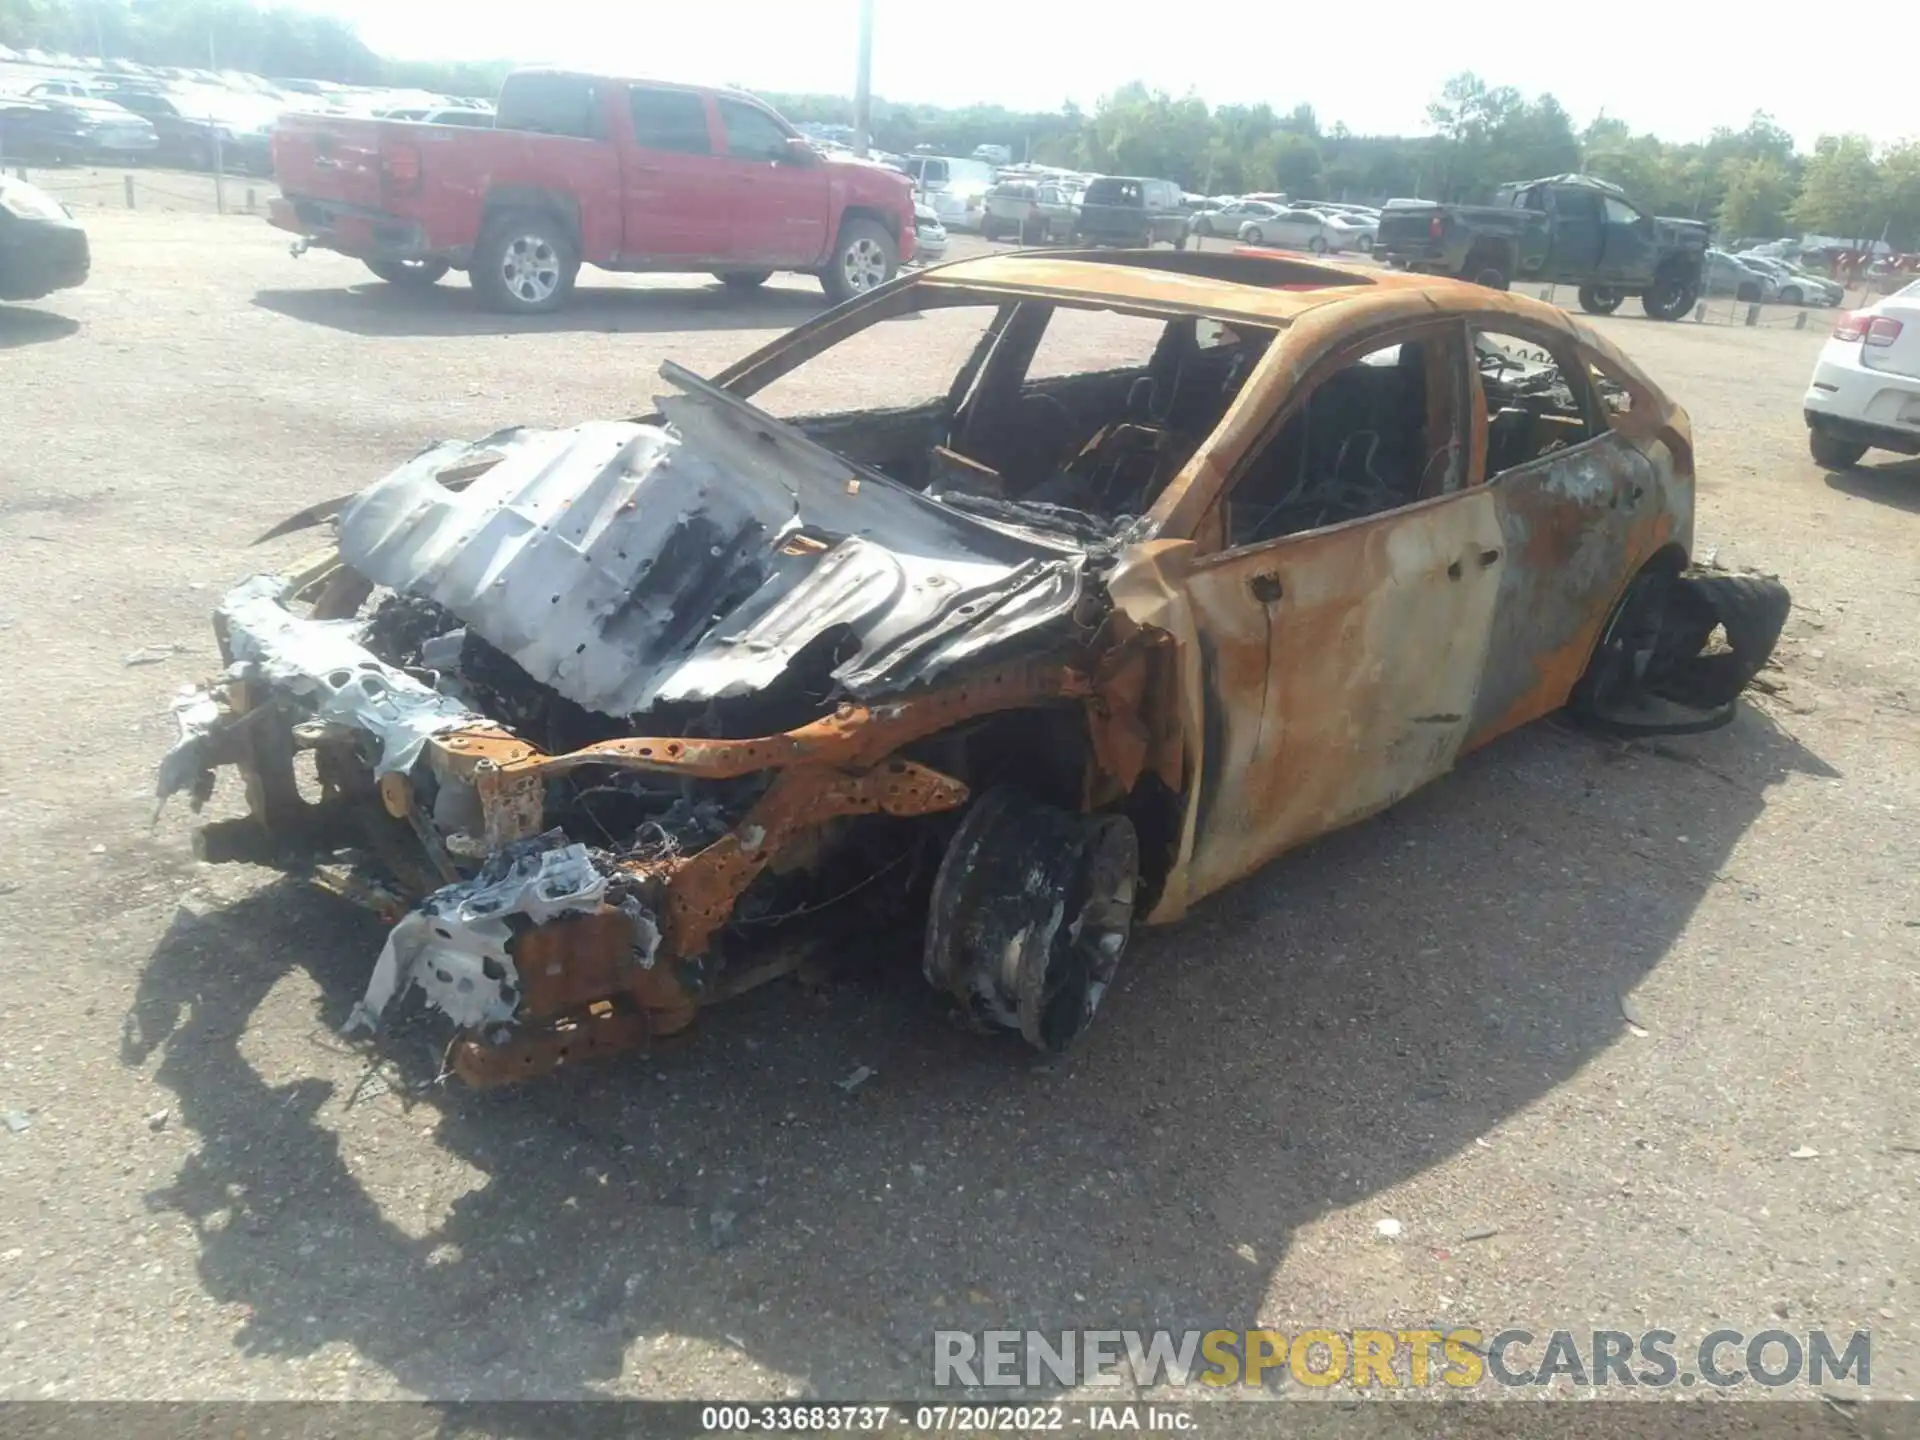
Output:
(1801, 280), (1920, 470)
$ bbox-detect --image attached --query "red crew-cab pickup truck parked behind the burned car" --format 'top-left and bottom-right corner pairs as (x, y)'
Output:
(269, 69), (914, 315)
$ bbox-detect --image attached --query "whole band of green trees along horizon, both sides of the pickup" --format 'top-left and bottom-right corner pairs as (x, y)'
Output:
(0, 0), (1920, 250)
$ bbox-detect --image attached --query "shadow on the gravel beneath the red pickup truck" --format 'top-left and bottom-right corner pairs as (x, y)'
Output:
(253, 278), (828, 336)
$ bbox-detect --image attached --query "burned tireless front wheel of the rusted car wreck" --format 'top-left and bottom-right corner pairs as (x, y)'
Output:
(925, 785), (1140, 1054)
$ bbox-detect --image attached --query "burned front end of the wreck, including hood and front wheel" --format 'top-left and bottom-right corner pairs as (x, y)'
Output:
(159, 360), (1179, 1083)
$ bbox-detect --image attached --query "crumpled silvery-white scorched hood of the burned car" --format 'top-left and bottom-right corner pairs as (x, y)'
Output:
(340, 380), (1087, 716)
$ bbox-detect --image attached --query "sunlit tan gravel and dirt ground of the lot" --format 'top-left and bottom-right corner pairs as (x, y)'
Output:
(0, 209), (1920, 1398)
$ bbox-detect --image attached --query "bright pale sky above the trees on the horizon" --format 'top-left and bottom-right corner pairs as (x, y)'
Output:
(314, 0), (1920, 146)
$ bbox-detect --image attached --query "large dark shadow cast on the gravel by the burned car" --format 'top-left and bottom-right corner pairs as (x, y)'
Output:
(125, 707), (1834, 1400)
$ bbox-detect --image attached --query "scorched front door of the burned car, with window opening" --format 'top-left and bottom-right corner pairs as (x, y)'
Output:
(1159, 323), (1501, 899)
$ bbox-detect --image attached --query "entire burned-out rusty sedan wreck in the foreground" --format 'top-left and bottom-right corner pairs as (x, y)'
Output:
(157, 252), (1788, 1085)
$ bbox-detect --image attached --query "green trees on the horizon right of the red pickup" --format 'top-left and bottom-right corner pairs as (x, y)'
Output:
(770, 73), (1920, 250)
